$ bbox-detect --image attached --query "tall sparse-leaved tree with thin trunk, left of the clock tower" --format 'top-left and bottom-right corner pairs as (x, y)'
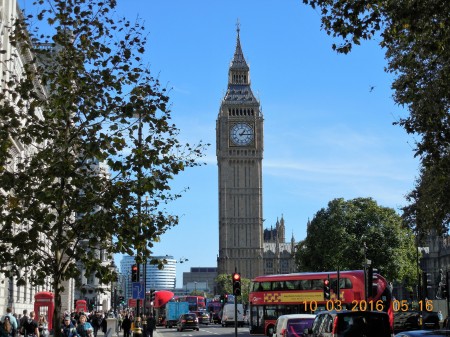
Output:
(0, 0), (204, 336)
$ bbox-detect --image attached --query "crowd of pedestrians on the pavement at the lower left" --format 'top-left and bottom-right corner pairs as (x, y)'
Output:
(0, 308), (156, 337)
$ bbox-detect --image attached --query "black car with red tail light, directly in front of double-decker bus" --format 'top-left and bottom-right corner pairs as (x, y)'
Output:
(306, 310), (394, 337)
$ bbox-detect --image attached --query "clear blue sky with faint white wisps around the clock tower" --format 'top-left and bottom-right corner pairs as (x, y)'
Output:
(21, 0), (418, 286)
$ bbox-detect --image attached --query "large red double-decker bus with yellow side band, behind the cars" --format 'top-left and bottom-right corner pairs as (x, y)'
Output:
(249, 270), (393, 336)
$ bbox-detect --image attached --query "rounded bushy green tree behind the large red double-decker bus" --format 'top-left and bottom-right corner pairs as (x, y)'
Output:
(295, 198), (417, 281)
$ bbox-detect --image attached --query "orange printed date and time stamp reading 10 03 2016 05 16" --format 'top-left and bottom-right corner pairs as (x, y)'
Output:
(301, 300), (433, 312)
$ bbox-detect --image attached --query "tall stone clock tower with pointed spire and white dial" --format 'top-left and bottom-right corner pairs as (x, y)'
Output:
(216, 25), (263, 278)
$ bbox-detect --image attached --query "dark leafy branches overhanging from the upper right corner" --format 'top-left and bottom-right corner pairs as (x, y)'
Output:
(303, 0), (450, 232)
